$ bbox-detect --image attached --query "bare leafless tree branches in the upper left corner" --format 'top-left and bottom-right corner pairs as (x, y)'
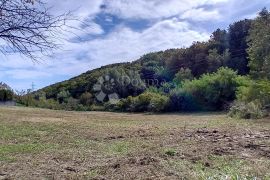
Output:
(0, 0), (71, 61)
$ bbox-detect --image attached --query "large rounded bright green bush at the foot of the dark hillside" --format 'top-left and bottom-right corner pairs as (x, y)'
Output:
(183, 68), (243, 110)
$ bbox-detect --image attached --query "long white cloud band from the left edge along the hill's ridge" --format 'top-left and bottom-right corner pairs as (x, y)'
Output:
(0, 18), (209, 87)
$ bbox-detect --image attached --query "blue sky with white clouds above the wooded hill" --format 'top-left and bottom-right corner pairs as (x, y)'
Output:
(0, 0), (270, 90)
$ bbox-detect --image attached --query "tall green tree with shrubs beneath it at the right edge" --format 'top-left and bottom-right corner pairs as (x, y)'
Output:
(230, 8), (270, 119)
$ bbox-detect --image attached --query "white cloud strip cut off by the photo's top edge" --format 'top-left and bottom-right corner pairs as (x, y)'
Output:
(102, 0), (229, 19)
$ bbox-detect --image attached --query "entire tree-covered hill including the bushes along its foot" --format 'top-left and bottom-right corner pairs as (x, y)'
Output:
(16, 8), (270, 118)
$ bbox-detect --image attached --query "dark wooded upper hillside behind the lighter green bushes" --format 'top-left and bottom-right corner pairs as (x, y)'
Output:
(35, 17), (251, 98)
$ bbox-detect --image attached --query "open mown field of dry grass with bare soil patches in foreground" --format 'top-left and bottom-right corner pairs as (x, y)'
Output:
(0, 107), (270, 179)
